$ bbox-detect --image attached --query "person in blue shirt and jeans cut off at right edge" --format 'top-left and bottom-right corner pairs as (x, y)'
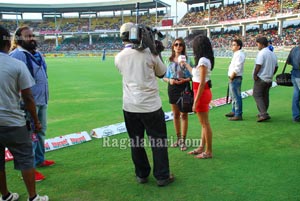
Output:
(287, 45), (300, 122)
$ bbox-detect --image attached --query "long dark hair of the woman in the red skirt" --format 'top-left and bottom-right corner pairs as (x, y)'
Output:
(193, 35), (215, 70)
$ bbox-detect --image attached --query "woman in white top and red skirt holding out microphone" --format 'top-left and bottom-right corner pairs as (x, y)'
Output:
(182, 35), (215, 159)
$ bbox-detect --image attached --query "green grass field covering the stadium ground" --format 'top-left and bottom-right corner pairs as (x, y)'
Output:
(7, 58), (300, 201)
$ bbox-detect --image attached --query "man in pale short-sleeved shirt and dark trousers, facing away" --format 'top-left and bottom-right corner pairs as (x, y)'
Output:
(253, 37), (278, 122)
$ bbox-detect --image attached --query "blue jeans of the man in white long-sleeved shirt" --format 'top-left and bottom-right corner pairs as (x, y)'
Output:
(229, 77), (243, 117)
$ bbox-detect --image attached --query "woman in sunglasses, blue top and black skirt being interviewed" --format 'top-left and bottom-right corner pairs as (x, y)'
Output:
(164, 38), (192, 151)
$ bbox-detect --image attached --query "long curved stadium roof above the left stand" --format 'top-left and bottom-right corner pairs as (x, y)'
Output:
(0, 0), (170, 13)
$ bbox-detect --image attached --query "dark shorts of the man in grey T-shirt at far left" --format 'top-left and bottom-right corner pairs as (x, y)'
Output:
(0, 126), (34, 170)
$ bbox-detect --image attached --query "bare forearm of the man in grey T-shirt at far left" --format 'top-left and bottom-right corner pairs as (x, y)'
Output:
(21, 88), (42, 131)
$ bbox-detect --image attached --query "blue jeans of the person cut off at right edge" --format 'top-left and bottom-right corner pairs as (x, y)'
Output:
(292, 76), (300, 121)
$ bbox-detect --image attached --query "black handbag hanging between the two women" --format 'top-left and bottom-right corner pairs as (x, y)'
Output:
(176, 82), (194, 113)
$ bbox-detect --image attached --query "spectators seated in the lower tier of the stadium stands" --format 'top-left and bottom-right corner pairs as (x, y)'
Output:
(39, 23), (300, 53)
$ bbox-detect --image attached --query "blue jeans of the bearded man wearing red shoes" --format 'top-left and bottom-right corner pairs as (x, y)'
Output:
(34, 105), (48, 165)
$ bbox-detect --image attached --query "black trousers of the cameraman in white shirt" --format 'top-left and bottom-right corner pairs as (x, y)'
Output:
(123, 108), (170, 180)
